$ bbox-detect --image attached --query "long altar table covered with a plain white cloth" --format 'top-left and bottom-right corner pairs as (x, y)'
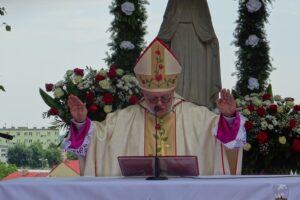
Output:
(0, 176), (300, 200)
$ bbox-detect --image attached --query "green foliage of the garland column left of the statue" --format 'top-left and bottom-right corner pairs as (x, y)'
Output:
(105, 0), (148, 72)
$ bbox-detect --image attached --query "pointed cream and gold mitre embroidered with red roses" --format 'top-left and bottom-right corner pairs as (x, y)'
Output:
(134, 38), (181, 92)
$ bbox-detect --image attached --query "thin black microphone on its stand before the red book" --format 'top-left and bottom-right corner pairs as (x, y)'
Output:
(146, 105), (168, 180)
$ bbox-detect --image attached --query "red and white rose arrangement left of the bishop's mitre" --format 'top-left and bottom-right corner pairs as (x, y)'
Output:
(40, 66), (141, 127)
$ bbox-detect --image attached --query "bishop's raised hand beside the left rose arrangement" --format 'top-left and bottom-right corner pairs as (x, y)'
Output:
(68, 94), (87, 122)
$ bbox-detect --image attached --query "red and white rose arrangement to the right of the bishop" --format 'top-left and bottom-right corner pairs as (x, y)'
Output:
(236, 87), (300, 174)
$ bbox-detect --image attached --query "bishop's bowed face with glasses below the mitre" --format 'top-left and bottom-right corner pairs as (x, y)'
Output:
(142, 90), (174, 117)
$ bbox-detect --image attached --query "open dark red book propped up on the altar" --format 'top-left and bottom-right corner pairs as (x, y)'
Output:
(118, 156), (199, 176)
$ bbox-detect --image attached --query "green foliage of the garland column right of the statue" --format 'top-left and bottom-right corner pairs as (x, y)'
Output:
(233, 0), (273, 96)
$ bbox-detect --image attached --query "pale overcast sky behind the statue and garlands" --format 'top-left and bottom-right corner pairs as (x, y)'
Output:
(0, 0), (300, 127)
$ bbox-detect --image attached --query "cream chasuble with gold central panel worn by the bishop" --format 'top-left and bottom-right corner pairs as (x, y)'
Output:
(80, 98), (242, 176)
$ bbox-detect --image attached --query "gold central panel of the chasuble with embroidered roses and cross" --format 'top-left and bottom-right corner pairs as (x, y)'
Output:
(144, 112), (176, 156)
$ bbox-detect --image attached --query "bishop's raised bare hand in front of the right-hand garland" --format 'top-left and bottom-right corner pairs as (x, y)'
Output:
(216, 89), (236, 117)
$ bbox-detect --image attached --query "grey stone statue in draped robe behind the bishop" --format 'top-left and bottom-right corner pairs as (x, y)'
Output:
(158, 0), (221, 109)
